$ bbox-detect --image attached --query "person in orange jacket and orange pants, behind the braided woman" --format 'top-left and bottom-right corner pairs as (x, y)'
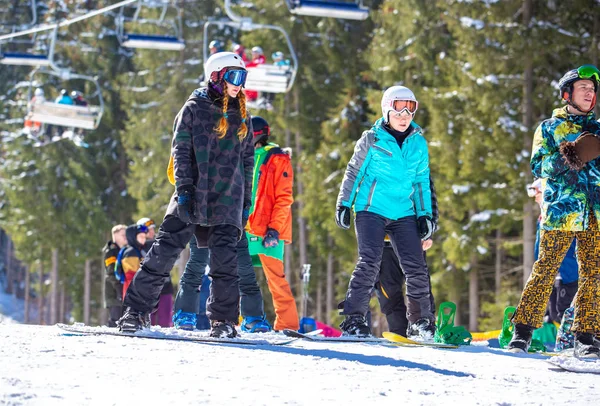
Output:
(246, 116), (300, 331)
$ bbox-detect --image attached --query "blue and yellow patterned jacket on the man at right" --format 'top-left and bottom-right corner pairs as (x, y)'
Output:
(531, 107), (600, 231)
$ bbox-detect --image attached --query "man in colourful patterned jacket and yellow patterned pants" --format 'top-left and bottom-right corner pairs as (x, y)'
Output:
(508, 65), (600, 357)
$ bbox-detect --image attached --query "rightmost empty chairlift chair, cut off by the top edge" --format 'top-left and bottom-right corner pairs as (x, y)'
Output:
(286, 0), (369, 20)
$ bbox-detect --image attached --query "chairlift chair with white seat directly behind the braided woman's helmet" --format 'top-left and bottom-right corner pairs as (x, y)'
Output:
(202, 0), (298, 93)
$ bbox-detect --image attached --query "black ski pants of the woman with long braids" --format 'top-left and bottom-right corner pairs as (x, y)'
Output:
(125, 214), (240, 323)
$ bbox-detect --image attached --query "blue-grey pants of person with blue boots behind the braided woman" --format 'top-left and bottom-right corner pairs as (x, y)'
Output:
(174, 233), (264, 317)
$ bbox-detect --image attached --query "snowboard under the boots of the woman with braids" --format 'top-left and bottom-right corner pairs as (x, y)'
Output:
(56, 323), (298, 345)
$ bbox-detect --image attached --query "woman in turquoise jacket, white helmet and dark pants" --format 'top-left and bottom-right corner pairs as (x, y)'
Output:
(336, 86), (435, 340)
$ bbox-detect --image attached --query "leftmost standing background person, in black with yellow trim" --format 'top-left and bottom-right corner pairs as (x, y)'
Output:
(102, 224), (127, 327)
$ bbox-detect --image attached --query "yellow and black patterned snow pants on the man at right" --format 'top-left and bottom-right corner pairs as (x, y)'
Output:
(512, 215), (600, 334)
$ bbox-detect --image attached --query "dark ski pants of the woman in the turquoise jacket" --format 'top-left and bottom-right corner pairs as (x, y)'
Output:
(343, 211), (434, 323)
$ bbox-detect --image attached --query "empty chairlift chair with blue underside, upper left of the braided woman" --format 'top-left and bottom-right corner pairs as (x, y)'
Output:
(116, 0), (185, 51)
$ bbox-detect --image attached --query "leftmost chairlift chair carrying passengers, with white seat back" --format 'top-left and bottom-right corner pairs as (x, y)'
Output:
(26, 69), (104, 130)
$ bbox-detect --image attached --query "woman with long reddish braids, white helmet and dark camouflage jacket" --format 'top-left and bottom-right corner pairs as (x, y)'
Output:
(119, 52), (254, 338)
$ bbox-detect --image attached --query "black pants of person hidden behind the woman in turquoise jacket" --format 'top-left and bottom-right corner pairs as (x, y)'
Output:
(375, 242), (435, 337)
